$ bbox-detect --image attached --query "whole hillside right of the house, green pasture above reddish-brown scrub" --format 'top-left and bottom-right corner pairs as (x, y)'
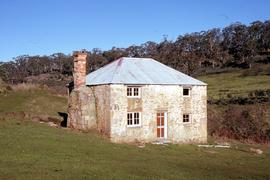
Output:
(198, 69), (270, 143)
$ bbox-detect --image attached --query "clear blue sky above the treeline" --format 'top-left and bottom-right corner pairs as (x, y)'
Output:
(0, 0), (270, 61)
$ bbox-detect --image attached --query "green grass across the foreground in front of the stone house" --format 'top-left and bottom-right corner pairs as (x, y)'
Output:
(0, 120), (270, 179)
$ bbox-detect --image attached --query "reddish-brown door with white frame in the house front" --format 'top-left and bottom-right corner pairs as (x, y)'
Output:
(157, 112), (167, 138)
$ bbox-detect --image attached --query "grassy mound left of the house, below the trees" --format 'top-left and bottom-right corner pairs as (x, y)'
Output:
(0, 87), (67, 123)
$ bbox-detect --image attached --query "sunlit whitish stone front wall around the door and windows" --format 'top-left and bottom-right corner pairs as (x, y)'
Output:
(110, 85), (207, 143)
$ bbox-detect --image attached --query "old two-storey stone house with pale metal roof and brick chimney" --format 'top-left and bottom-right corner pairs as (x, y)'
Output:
(68, 51), (207, 143)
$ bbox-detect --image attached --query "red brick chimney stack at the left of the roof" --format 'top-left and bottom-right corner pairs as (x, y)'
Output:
(73, 50), (87, 89)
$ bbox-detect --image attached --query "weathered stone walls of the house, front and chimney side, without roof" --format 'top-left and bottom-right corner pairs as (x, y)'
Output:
(68, 85), (207, 143)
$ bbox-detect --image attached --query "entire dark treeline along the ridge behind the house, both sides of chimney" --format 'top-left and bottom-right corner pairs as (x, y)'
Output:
(0, 21), (270, 83)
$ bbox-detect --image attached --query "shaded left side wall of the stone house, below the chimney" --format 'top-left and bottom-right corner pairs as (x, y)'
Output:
(67, 85), (111, 136)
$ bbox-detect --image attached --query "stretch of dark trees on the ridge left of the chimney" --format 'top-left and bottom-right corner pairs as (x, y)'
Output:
(0, 53), (73, 84)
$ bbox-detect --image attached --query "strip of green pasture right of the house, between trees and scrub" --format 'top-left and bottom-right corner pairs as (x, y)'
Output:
(197, 71), (270, 99)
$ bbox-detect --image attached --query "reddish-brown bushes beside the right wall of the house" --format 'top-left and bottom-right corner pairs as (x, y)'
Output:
(208, 105), (270, 143)
